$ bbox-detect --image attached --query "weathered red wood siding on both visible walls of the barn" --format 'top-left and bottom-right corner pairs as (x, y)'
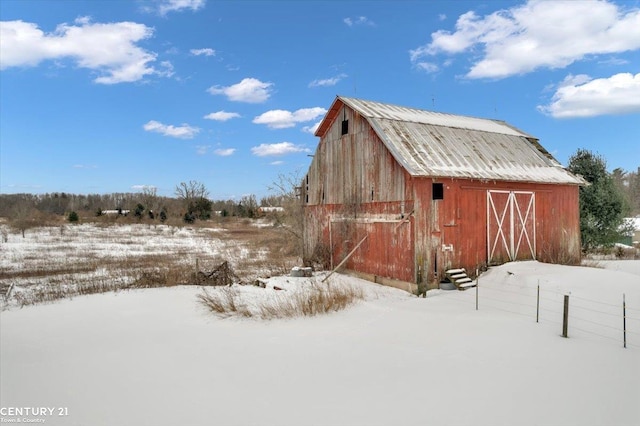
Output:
(302, 102), (580, 288)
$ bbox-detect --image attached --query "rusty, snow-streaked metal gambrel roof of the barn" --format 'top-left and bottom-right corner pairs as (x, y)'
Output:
(316, 96), (585, 185)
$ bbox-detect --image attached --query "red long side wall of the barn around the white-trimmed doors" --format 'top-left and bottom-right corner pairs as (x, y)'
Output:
(413, 178), (580, 287)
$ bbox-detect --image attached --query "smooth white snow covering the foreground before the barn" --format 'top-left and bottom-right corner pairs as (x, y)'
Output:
(0, 261), (640, 426)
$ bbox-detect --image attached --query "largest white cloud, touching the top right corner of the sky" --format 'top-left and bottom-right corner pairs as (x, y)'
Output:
(410, 0), (640, 78)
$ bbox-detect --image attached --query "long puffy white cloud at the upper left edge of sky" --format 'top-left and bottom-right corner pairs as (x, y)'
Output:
(0, 17), (158, 84)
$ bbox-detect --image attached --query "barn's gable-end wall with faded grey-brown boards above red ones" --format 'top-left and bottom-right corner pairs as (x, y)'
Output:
(302, 108), (415, 282)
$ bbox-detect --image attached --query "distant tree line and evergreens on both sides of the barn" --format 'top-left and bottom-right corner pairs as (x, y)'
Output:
(0, 156), (640, 252)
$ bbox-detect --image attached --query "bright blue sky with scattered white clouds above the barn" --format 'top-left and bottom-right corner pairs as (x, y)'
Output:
(0, 0), (640, 199)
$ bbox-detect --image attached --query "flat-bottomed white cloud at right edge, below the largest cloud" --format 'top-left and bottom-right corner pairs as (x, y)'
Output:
(538, 73), (640, 118)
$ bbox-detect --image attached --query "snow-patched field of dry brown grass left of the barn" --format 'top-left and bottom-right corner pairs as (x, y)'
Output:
(0, 220), (297, 306)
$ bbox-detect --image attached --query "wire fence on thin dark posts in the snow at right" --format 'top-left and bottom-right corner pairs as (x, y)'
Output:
(438, 281), (640, 349)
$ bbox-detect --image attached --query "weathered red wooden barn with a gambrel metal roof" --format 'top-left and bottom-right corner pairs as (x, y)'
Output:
(302, 96), (584, 292)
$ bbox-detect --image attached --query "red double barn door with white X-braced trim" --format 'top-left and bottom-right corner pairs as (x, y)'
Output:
(487, 190), (536, 263)
